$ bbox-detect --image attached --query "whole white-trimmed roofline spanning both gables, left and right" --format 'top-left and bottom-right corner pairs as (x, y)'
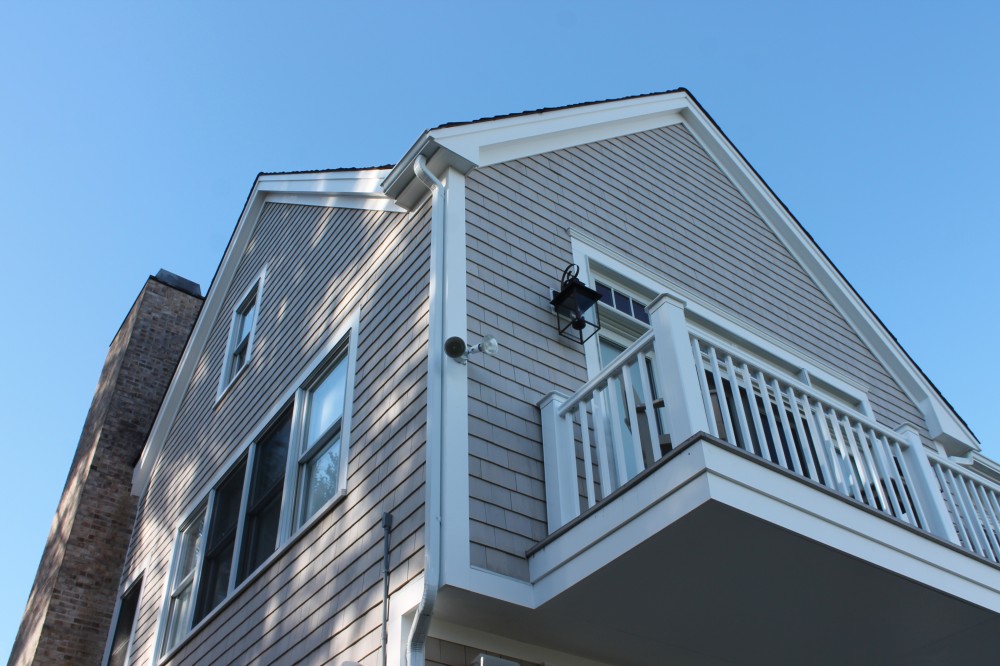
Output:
(133, 88), (979, 494)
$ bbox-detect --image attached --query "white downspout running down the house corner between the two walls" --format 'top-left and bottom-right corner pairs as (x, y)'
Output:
(407, 155), (448, 666)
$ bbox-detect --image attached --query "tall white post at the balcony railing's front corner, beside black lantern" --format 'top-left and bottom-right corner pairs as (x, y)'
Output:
(646, 294), (710, 446)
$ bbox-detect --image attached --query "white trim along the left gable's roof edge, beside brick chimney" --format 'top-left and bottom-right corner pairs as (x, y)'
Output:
(132, 169), (394, 496)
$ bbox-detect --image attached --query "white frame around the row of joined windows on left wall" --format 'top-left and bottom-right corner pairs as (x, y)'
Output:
(155, 312), (360, 663)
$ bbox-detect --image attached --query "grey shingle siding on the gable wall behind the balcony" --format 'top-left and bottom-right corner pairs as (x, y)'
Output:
(467, 125), (923, 578)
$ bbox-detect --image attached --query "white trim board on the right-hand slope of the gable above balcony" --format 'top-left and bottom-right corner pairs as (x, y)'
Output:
(682, 104), (979, 453)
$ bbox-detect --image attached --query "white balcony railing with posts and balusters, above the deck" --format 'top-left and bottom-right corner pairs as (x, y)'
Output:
(539, 296), (1000, 563)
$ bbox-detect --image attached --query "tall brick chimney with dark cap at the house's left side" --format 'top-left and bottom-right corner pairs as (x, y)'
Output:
(9, 271), (202, 666)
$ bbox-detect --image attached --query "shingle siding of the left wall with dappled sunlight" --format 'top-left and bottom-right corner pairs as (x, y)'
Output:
(120, 204), (430, 664)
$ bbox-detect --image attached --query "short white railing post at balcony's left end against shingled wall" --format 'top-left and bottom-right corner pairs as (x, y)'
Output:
(538, 391), (580, 534)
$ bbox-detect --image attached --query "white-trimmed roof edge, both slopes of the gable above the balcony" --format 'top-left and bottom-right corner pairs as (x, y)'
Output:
(382, 88), (979, 453)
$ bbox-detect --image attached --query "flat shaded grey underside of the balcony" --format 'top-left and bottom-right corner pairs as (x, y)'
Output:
(437, 500), (1000, 664)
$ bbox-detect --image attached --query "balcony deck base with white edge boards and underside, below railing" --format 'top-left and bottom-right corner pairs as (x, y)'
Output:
(439, 435), (1000, 664)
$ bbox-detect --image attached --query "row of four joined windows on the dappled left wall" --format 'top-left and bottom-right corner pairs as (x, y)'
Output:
(160, 337), (353, 655)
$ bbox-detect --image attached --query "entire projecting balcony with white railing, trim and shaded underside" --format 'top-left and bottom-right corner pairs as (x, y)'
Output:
(516, 296), (1000, 664)
